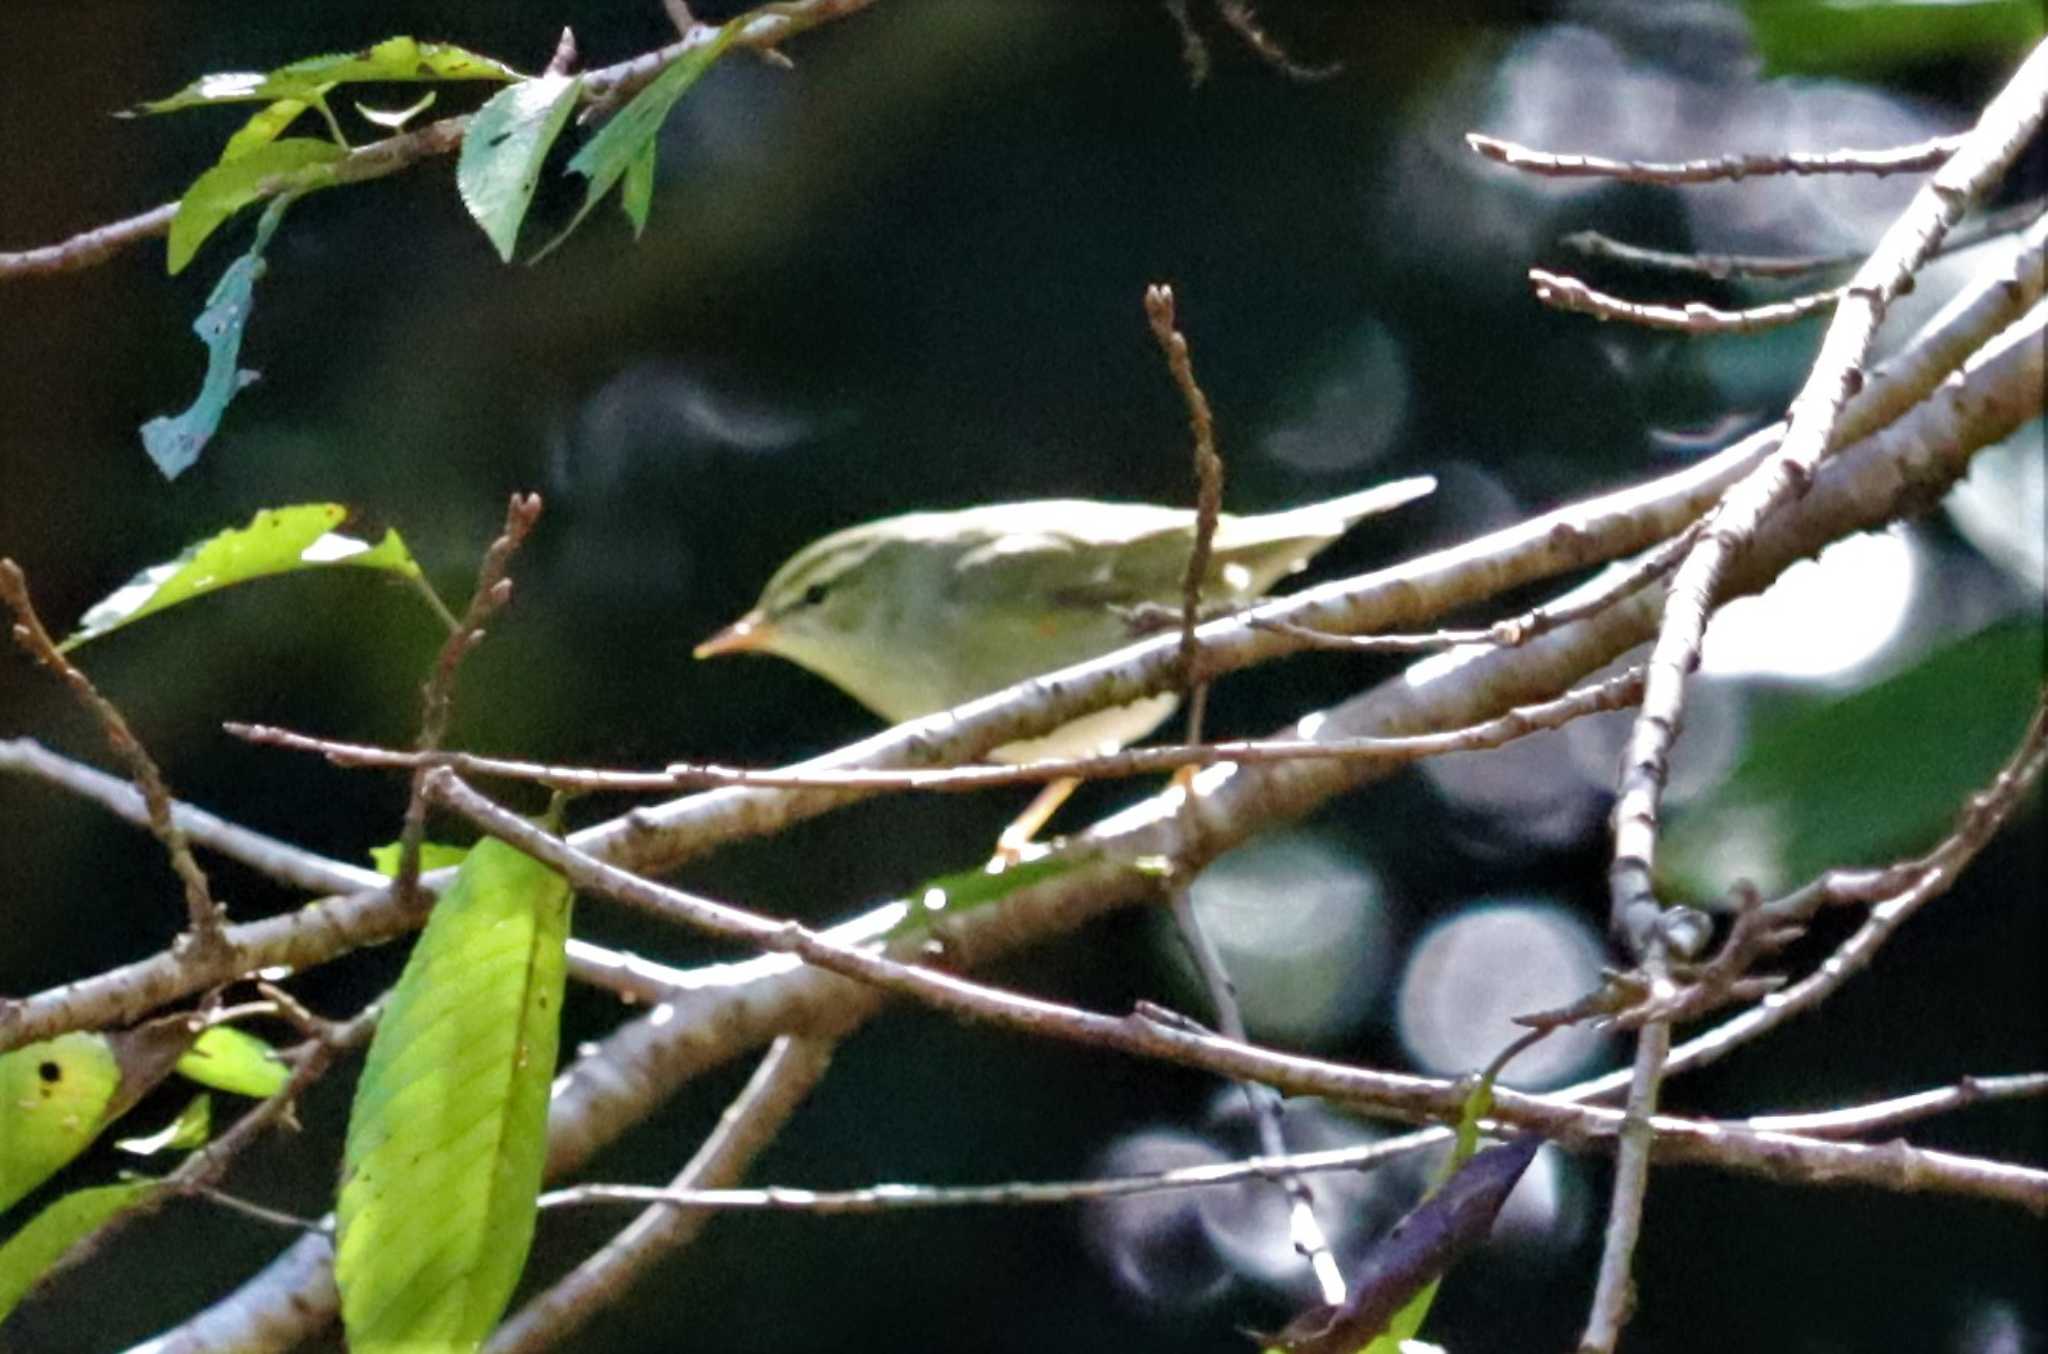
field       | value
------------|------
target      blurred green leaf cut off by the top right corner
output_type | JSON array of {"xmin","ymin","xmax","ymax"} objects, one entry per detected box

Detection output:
[{"xmin": 1743, "ymin": 0, "xmax": 2044, "ymax": 78}]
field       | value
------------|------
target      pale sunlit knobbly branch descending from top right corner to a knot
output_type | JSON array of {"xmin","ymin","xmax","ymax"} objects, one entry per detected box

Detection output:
[{"xmin": 1610, "ymin": 41, "xmax": 2048, "ymax": 953}]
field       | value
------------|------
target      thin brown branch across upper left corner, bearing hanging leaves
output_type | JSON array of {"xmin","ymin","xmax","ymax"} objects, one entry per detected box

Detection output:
[{"xmin": 0, "ymin": 0, "xmax": 874, "ymax": 283}]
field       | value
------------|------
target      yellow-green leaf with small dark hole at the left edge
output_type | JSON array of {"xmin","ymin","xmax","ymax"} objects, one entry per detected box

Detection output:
[{"xmin": 0, "ymin": 1030, "xmax": 121, "ymax": 1213}]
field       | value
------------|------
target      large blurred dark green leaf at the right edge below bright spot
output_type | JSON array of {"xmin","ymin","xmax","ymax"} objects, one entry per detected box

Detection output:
[{"xmin": 1657, "ymin": 617, "xmax": 2048, "ymax": 899}]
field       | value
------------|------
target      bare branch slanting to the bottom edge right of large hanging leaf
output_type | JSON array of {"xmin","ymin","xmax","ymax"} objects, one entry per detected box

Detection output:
[{"xmin": 483, "ymin": 1034, "xmax": 836, "ymax": 1354}]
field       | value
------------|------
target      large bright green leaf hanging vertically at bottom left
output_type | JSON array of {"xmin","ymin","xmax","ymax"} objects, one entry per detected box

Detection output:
[{"xmin": 334, "ymin": 840, "xmax": 569, "ymax": 1354}]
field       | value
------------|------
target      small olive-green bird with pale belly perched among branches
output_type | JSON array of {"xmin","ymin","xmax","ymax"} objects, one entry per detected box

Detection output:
[{"xmin": 696, "ymin": 475, "xmax": 1436, "ymax": 762}]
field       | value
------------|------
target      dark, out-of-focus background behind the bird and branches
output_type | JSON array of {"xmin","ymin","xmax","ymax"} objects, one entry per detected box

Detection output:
[{"xmin": 0, "ymin": 0, "xmax": 2044, "ymax": 1354}]
